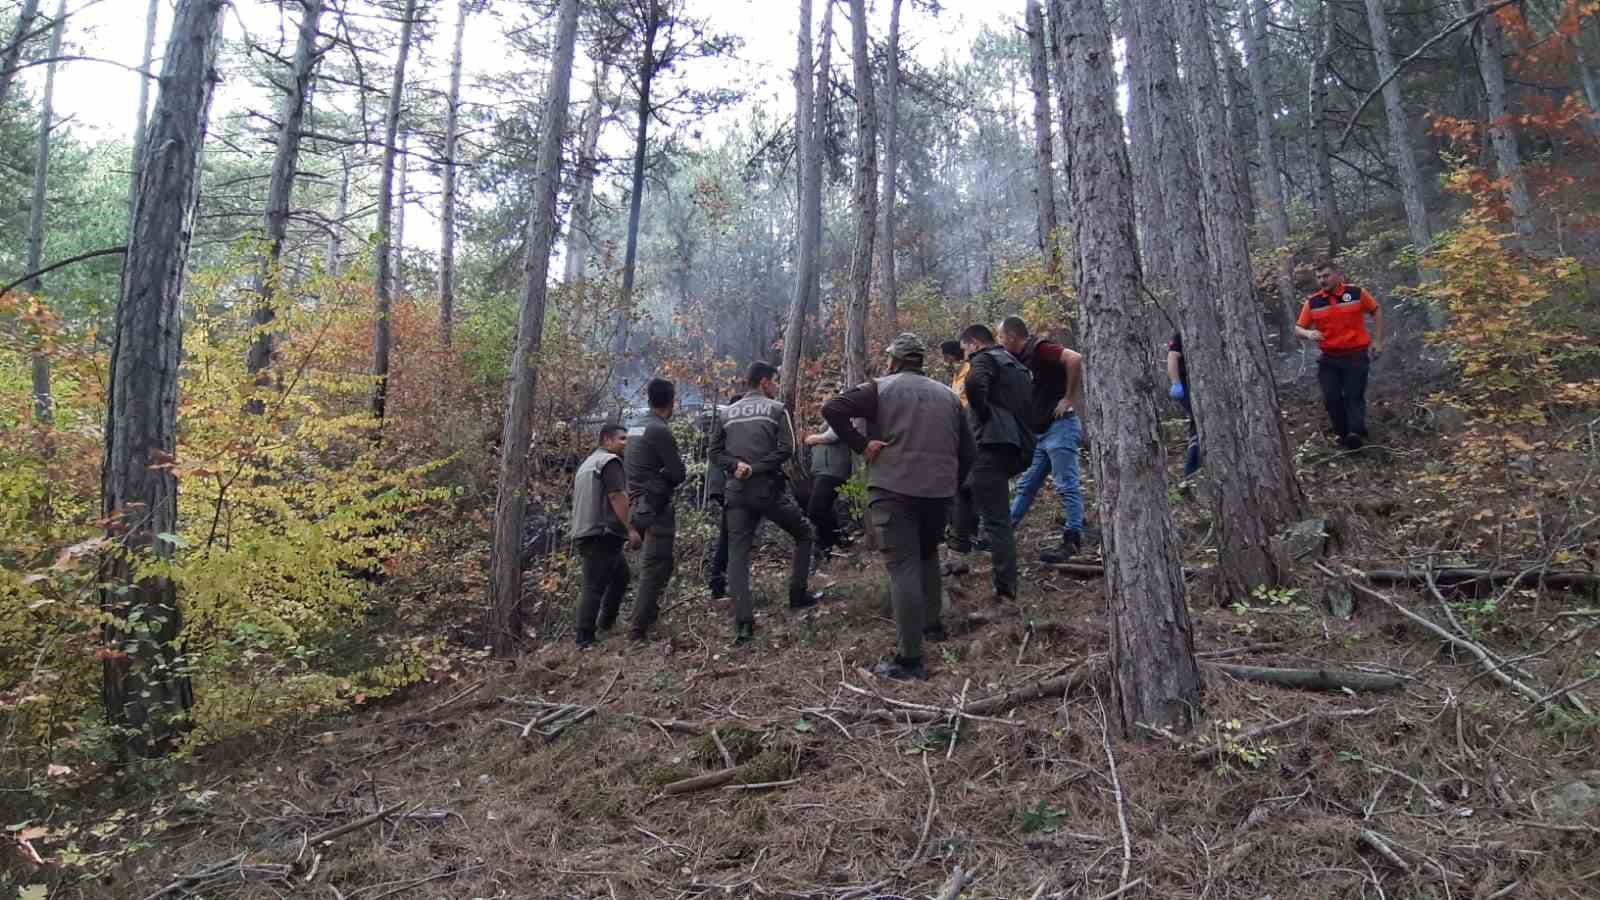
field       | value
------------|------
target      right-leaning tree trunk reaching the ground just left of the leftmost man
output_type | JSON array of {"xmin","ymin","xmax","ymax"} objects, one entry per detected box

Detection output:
[{"xmin": 490, "ymin": 0, "xmax": 578, "ymax": 657}]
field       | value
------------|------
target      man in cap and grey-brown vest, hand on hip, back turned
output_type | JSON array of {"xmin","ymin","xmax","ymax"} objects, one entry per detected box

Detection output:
[{"xmin": 822, "ymin": 331, "xmax": 978, "ymax": 679}]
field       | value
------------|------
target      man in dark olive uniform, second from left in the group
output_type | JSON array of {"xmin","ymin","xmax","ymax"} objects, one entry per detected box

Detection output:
[{"xmin": 624, "ymin": 378, "xmax": 688, "ymax": 641}]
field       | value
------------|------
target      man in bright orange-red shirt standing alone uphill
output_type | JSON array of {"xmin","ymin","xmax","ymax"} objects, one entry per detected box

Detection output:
[{"xmin": 1294, "ymin": 259, "xmax": 1384, "ymax": 450}]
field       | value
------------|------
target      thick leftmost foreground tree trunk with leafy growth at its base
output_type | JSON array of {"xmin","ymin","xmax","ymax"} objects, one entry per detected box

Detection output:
[{"xmin": 99, "ymin": 0, "xmax": 226, "ymax": 754}]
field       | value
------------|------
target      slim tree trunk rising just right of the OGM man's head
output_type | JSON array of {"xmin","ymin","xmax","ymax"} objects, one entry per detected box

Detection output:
[{"xmin": 778, "ymin": 0, "xmax": 832, "ymax": 410}]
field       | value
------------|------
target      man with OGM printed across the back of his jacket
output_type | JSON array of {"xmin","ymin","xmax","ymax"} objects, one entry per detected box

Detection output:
[{"xmin": 710, "ymin": 362, "xmax": 816, "ymax": 644}]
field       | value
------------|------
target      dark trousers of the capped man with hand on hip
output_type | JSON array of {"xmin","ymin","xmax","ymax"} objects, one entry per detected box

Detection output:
[{"xmin": 867, "ymin": 488, "xmax": 950, "ymax": 660}]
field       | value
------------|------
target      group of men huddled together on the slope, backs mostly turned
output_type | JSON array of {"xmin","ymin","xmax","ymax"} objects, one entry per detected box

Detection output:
[{"xmin": 571, "ymin": 317, "xmax": 1083, "ymax": 679}]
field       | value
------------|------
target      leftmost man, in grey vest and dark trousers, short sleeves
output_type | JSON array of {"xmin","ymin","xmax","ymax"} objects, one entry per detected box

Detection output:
[{"xmin": 571, "ymin": 424, "xmax": 640, "ymax": 647}]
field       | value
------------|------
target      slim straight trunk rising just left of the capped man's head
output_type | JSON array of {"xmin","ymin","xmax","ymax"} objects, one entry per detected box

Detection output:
[{"xmin": 845, "ymin": 0, "xmax": 878, "ymax": 384}]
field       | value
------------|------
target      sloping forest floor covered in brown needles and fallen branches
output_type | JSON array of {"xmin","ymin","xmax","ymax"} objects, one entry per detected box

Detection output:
[{"xmin": 6, "ymin": 339, "xmax": 1600, "ymax": 900}]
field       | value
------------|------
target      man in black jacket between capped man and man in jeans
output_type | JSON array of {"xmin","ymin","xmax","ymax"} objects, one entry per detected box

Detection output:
[{"xmin": 957, "ymin": 325, "xmax": 1035, "ymax": 601}]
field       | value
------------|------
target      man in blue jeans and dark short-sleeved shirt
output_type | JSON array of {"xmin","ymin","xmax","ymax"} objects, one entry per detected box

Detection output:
[{"xmin": 1000, "ymin": 315, "xmax": 1083, "ymax": 564}]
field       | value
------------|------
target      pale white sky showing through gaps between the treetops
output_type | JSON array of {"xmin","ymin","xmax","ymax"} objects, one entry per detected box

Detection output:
[{"xmin": 27, "ymin": 0, "xmax": 1022, "ymax": 248}]
